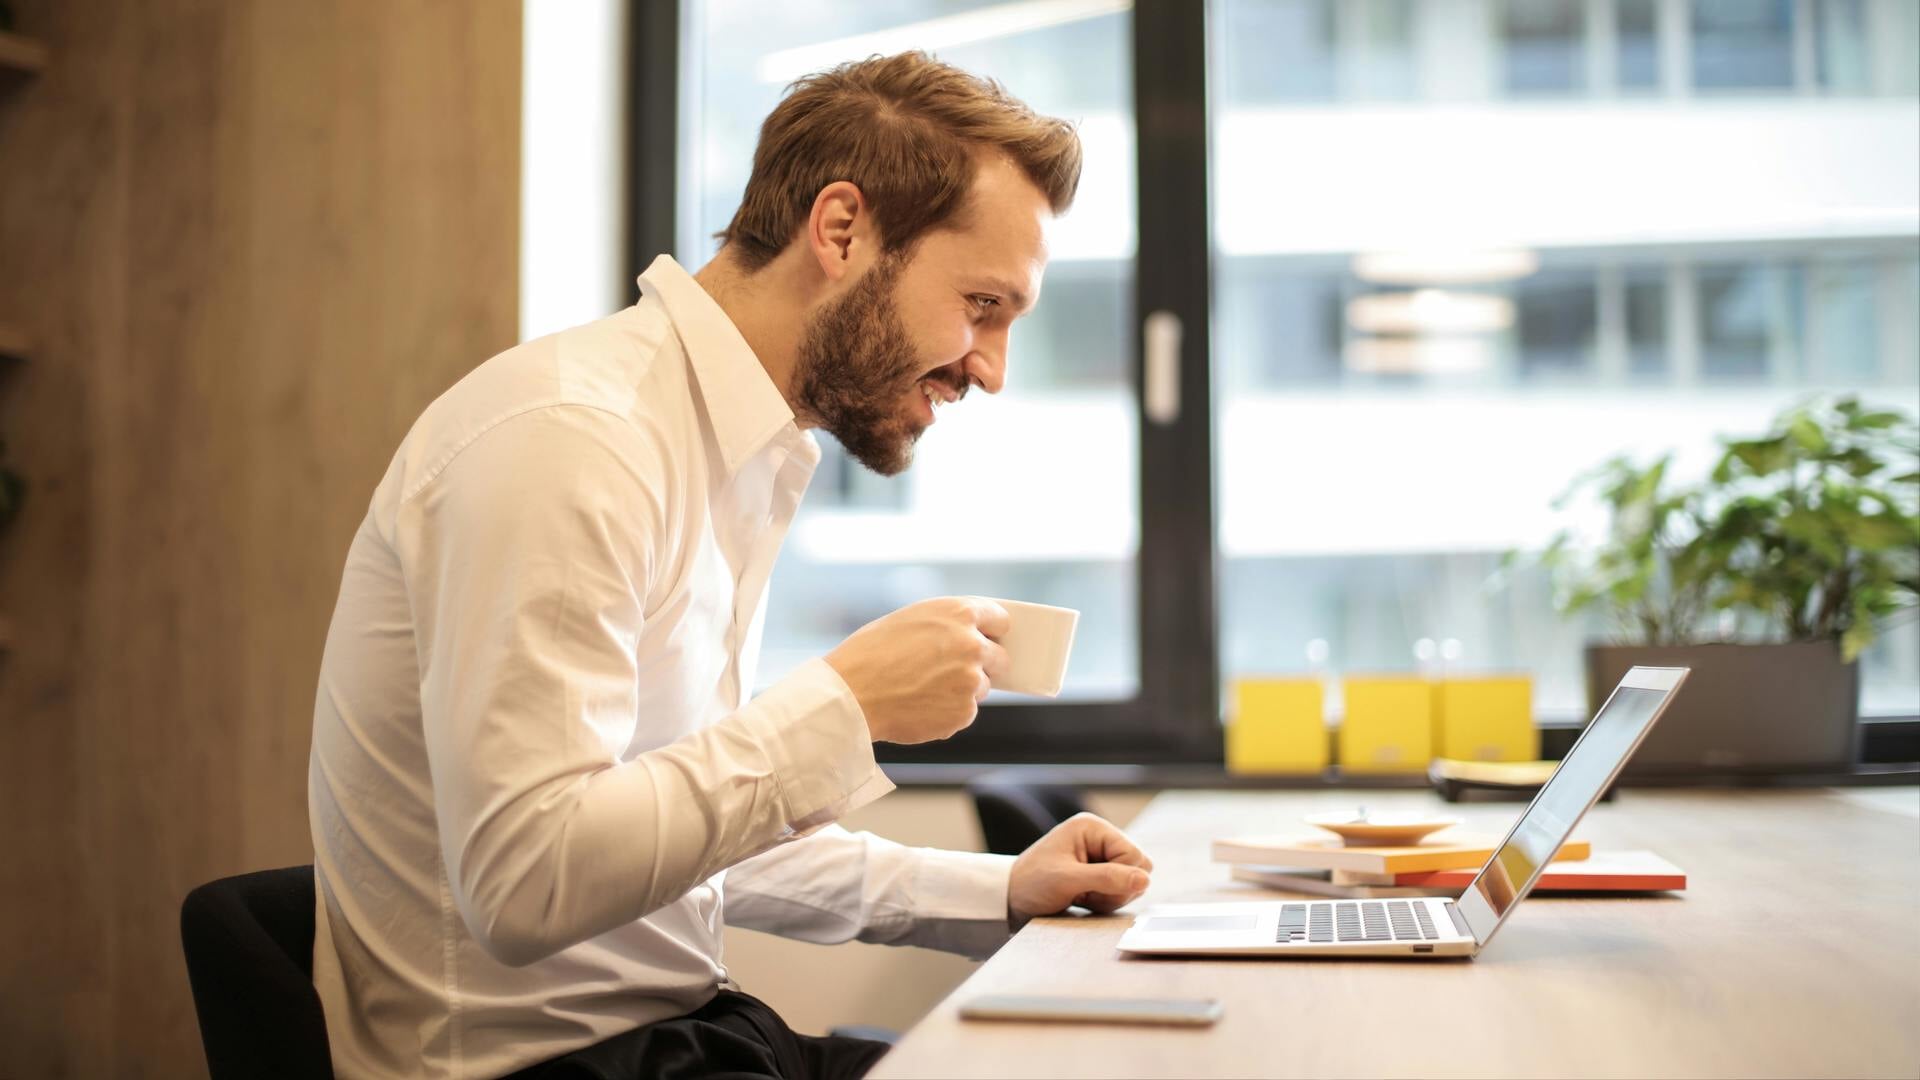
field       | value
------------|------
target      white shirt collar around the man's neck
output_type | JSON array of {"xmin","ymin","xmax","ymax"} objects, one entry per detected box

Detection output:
[{"xmin": 639, "ymin": 256, "xmax": 799, "ymax": 475}]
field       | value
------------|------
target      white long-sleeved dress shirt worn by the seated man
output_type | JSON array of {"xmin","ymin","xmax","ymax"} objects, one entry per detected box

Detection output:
[{"xmin": 307, "ymin": 256, "xmax": 1010, "ymax": 1078}]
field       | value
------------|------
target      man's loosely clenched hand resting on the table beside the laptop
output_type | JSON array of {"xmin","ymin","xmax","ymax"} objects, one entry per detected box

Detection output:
[{"xmin": 1006, "ymin": 813, "xmax": 1154, "ymax": 930}]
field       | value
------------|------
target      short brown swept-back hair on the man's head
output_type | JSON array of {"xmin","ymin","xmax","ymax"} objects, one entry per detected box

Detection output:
[{"xmin": 718, "ymin": 52, "xmax": 1081, "ymax": 273}]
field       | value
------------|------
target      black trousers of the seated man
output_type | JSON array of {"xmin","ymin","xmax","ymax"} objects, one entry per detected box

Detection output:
[{"xmin": 507, "ymin": 990, "xmax": 889, "ymax": 1080}]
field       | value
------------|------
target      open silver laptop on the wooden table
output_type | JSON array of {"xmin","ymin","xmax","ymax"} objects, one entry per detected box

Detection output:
[{"xmin": 1119, "ymin": 667, "xmax": 1690, "ymax": 957}]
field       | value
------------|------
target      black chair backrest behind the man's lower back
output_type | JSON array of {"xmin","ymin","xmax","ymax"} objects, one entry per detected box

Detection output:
[{"xmin": 180, "ymin": 867, "xmax": 334, "ymax": 1080}]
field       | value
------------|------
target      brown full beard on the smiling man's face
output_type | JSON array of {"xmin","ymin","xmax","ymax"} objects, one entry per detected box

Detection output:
[{"xmin": 793, "ymin": 256, "xmax": 944, "ymax": 477}]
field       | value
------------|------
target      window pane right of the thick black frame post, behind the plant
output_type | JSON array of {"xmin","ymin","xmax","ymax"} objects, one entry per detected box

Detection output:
[{"xmin": 1212, "ymin": 0, "xmax": 1920, "ymax": 717}]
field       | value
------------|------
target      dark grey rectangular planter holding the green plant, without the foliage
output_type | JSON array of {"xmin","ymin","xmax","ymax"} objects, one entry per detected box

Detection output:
[{"xmin": 1586, "ymin": 642, "xmax": 1860, "ymax": 776}]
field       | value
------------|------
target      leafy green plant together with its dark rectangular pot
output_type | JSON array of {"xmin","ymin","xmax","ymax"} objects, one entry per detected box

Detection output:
[{"xmin": 1544, "ymin": 398, "xmax": 1920, "ymax": 773}]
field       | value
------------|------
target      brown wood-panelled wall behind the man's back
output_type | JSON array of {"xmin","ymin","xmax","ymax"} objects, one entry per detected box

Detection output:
[{"xmin": 0, "ymin": 0, "xmax": 520, "ymax": 1080}]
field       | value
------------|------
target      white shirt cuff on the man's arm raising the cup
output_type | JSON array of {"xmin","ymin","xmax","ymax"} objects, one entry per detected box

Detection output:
[{"xmin": 743, "ymin": 645, "xmax": 893, "ymax": 840}]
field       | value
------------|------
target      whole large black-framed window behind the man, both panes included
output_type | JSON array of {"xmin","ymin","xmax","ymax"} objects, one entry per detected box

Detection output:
[{"xmin": 637, "ymin": 0, "xmax": 1920, "ymax": 761}]
